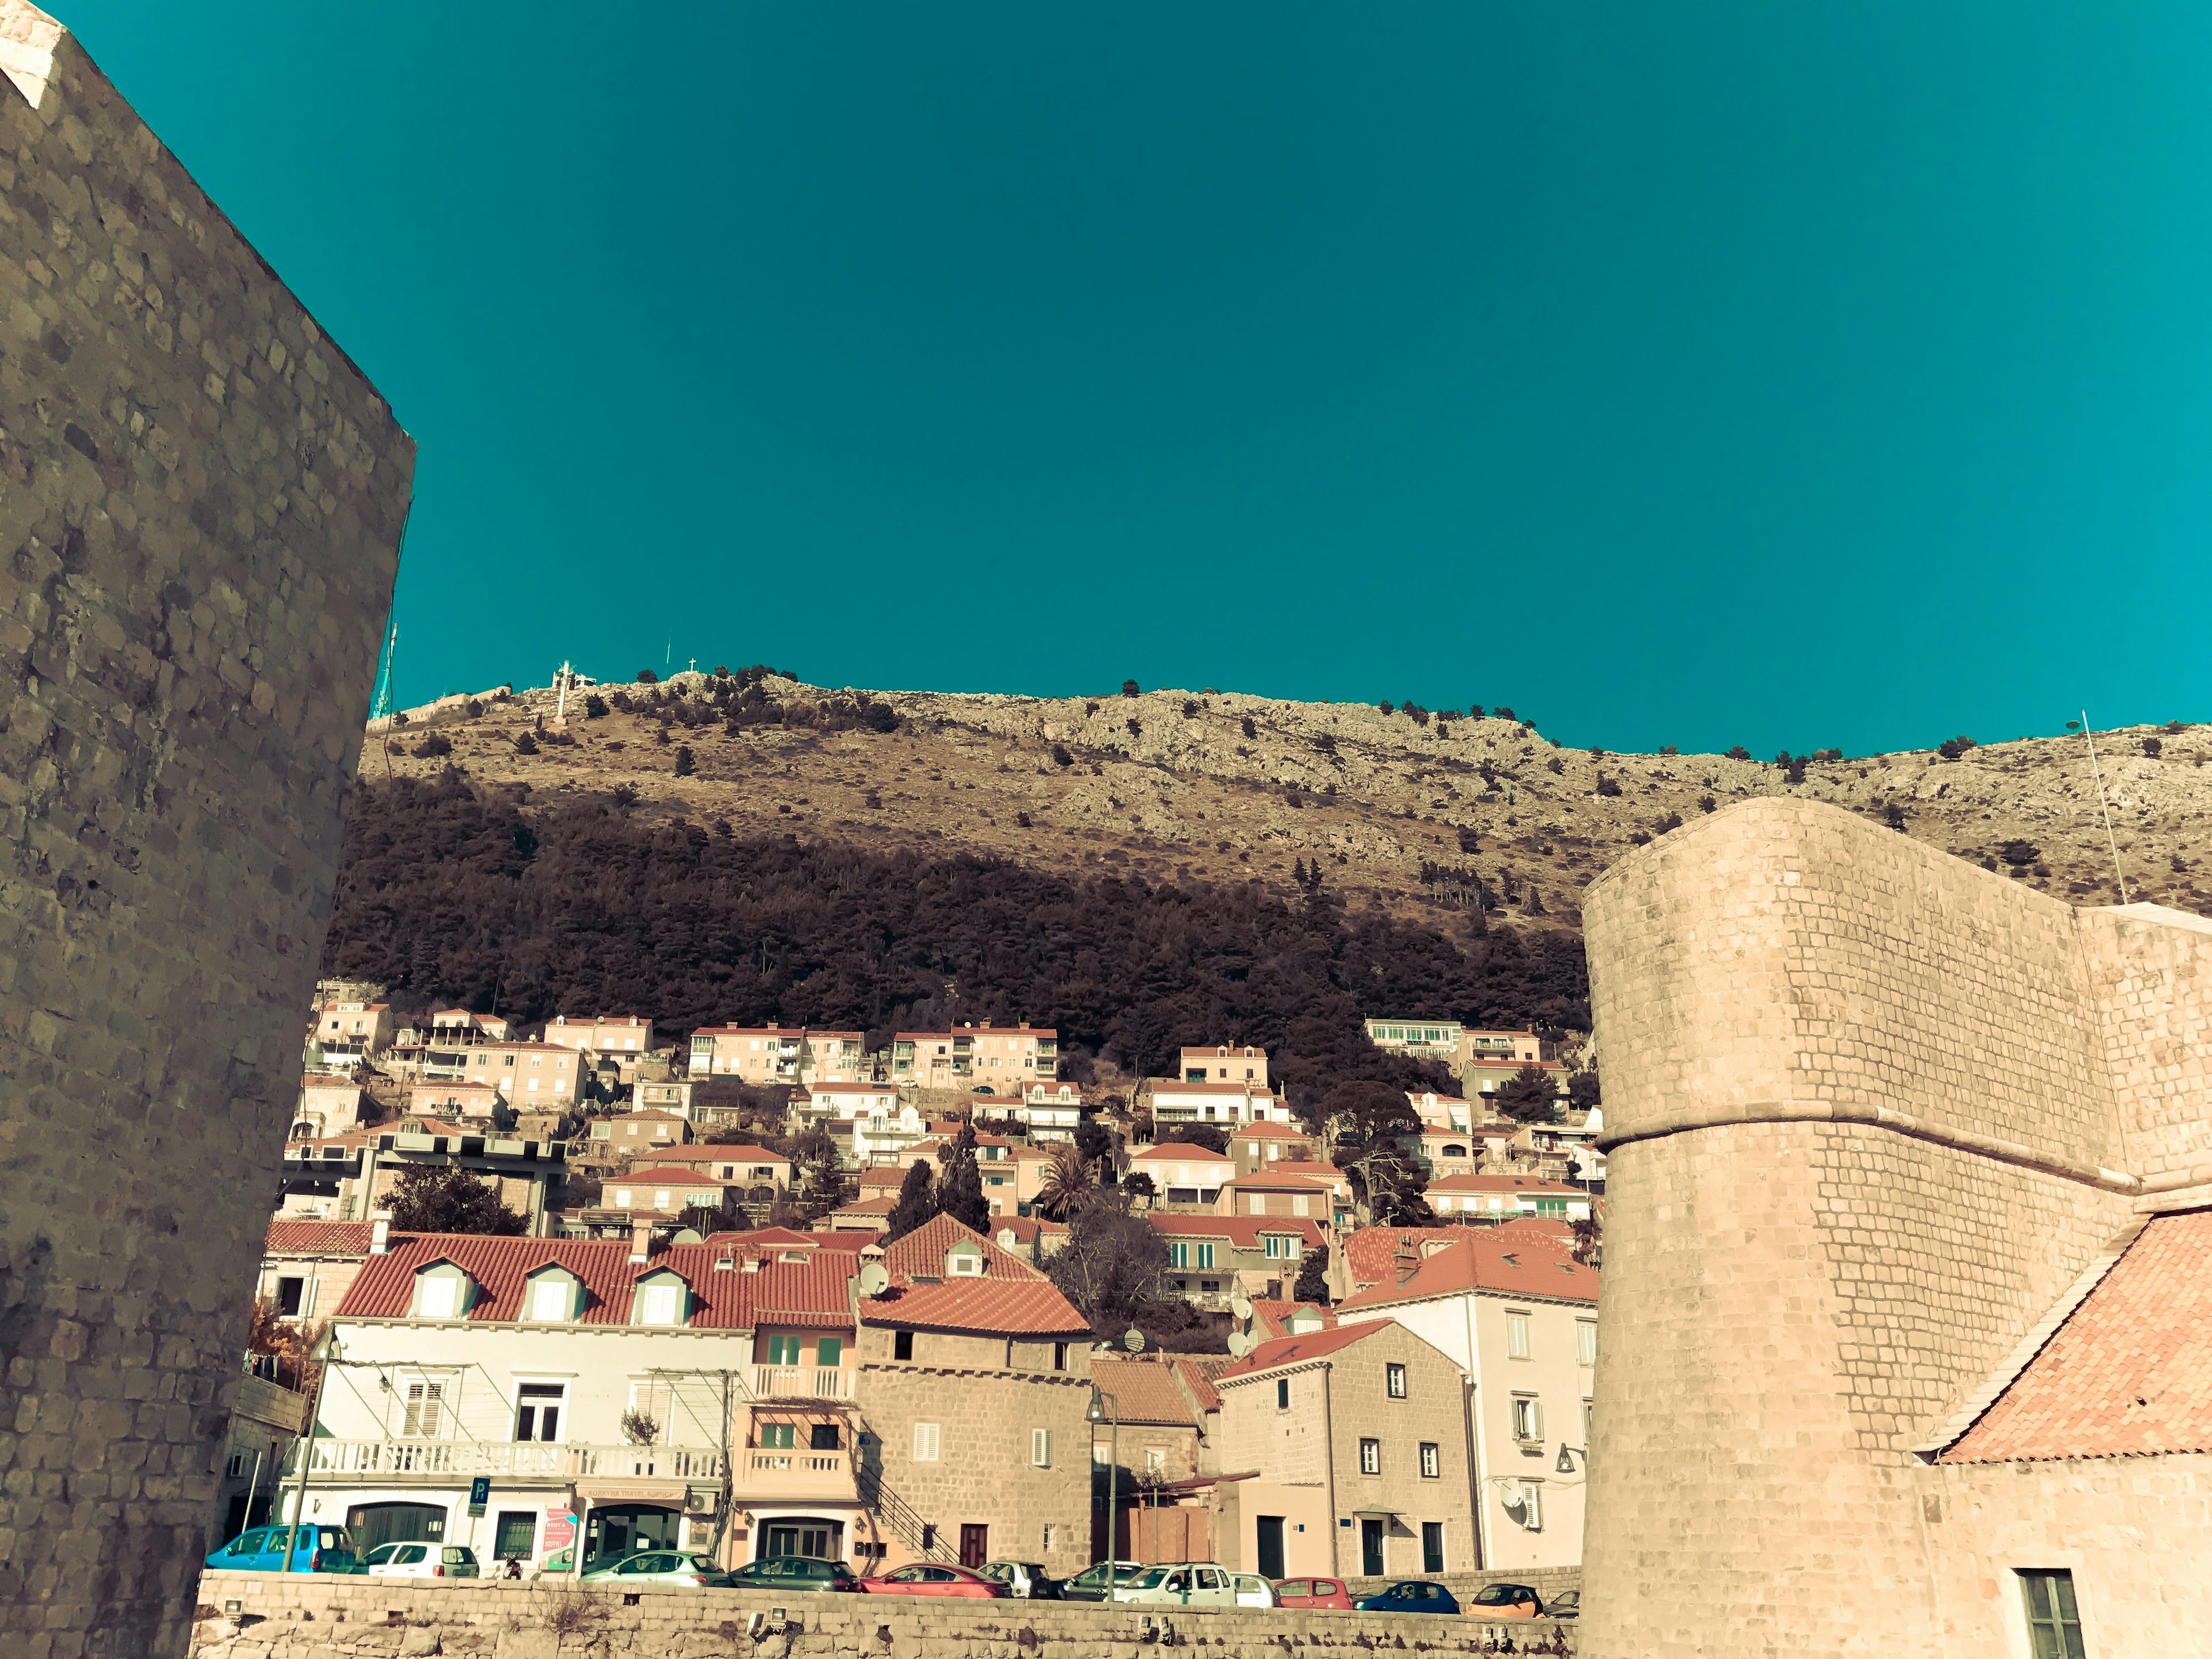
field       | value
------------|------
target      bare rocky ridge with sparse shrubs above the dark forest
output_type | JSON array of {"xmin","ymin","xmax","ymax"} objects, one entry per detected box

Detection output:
[{"xmin": 363, "ymin": 675, "xmax": 2212, "ymax": 927}]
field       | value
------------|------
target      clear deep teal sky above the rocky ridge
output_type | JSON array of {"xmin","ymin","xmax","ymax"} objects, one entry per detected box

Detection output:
[{"xmin": 55, "ymin": 0, "xmax": 2212, "ymax": 754}]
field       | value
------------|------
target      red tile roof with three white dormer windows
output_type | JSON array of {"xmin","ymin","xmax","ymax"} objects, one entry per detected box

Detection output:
[{"xmin": 339, "ymin": 1232, "xmax": 851, "ymax": 1330}]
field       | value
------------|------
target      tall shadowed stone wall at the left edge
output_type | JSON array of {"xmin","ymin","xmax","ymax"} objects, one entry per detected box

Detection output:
[{"xmin": 0, "ymin": 0, "xmax": 414, "ymax": 1659}]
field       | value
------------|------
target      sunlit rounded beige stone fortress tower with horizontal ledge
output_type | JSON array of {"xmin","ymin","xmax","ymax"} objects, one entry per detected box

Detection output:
[{"xmin": 1584, "ymin": 798, "xmax": 2212, "ymax": 1659}]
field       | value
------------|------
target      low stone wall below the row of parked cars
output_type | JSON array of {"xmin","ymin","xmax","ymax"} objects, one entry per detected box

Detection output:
[{"xmin": 192, "ymin": 1573, "xmax": 1575, "ymax": 1659}]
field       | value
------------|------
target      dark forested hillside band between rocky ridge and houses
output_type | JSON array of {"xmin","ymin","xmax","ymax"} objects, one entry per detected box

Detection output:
[{"xmin": 323, "ymin": 772, "xmax": 1588, "ymax": 1104}]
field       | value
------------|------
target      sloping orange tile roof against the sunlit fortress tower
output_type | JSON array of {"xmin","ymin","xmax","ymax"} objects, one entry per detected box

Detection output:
[{"xmin": 1938, "ymin": 1210, "xmax": 2212, "ymax": 1462}]
